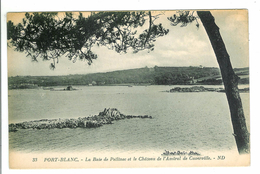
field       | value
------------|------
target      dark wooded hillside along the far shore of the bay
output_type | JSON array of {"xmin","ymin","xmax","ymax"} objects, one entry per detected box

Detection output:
[{"xmin": 8, "ymin": 66, "xmax": 249, "ymax": 89}]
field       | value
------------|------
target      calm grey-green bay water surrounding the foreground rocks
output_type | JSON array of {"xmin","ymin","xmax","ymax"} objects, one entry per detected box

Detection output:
[{"xmin": 8, "ymin": 86, "xmax": 249, "ymax": 152}]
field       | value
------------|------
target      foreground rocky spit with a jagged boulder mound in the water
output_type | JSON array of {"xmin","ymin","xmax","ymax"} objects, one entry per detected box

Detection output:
[{"xmin": 9, "ymin": 108, "xmax": 152, "ymax": 132}]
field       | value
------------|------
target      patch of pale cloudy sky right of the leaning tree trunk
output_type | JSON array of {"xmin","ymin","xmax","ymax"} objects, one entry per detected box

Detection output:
[{"xmin": 212, "ymin": 10, "xmax": 249, "ymax": 67}]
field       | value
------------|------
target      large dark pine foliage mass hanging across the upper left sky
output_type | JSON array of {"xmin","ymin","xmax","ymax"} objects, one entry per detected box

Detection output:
[{"xmin": 7, "ymin": 11, "xmax": 169, "ymax": 69}]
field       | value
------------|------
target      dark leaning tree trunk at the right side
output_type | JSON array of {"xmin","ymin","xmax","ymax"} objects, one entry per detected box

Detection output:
[{"xmin": 197, "ymin": 11, "xmax": 250, "ymax": 154}]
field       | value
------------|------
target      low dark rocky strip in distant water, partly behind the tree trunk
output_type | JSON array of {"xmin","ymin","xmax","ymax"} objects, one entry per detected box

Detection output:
[{"xmin": 166, "ymin": 86, "xmax": 249, "ymax": 93}]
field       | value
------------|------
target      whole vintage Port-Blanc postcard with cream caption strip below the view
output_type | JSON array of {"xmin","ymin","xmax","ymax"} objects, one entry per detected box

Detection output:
[{"xmin": 7, "ymin": 9, "xmax": 250, "ymax": 169}]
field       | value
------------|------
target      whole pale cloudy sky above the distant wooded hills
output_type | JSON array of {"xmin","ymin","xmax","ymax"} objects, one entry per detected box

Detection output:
[{"xmin": 7, "ymin": 10, "xmax": 249, "ymax": 76}]
